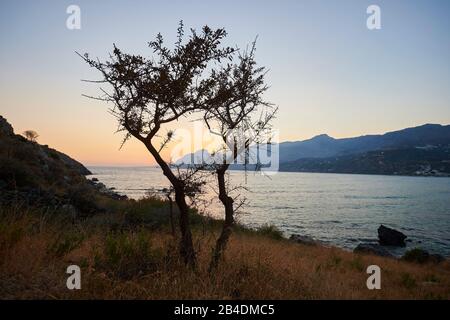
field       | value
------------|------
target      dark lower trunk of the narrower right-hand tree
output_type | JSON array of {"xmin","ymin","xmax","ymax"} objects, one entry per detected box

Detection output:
[{"xmin": 209, "ymin": 170, "xmax": 234, "ymax": 272}]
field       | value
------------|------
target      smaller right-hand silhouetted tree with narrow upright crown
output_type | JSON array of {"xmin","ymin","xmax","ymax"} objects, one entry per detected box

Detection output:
[{"xmin": 204, "ymin": 42, "xmax": 277, "ymax": 270}]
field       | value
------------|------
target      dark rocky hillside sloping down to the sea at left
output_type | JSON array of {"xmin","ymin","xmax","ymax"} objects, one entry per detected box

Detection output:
[{"xmin": 0, "ymin": 116, "xmax": 121, "ymax": 214}]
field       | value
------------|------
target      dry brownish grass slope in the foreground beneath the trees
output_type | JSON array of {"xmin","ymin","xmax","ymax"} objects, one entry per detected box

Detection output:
[{"xmin": 0, "ymin": 208, "xmax": 450, "ymax": 299}]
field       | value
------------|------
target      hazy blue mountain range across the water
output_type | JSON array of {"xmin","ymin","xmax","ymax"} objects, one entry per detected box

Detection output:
[{"xmin": 177, "ymin": 124, "xmax": 450, "ymax": 176}]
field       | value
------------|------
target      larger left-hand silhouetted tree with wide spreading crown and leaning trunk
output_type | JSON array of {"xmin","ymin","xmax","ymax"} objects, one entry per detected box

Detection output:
[{"xmin": 82, "ymin": 23, "xmax": 235, "ymax": 266}]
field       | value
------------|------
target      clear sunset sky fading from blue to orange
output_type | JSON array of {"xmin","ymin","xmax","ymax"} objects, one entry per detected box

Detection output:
[{"xmin": 0, "ymin": 0, "xmax": 450, "ymax": 165}]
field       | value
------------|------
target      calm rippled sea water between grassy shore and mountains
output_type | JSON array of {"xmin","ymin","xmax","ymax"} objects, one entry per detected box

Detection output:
[{"xmin": 89, "ymin": 167, "xmax": 450, "ymax": 256}]
